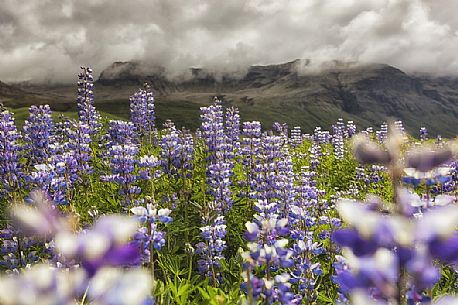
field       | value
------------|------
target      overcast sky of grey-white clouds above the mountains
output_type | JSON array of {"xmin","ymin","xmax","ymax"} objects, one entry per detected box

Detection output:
[{"xmin": 0, "ymin": 0, "xmax": 458, "ymax": 82}]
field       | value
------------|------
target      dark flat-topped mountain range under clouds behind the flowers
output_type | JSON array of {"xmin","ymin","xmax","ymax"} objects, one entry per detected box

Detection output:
[{"xmin": 3, "ymin": 60, "xmax": 458, "ymax": 137}]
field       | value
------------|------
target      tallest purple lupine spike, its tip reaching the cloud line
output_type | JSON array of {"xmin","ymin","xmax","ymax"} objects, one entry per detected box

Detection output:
[{"xmin": 76, "ymin": 66, "xmax": 102, "ymax": 135}]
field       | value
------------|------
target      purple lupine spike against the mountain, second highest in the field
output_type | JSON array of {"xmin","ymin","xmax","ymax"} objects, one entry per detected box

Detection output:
[{"xmin": 129, "ymin": 87, "xmax": 156, "ymax": 136}]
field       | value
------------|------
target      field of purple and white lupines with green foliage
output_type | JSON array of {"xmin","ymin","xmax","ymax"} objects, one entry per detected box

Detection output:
[{"xmin": 0, "ymin": 67, "xmax": 458, "ymax": 305}]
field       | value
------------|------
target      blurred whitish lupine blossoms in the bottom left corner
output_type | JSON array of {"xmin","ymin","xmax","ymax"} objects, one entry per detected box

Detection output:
[{"xmin": 0, "ymin": 264, "xmax": 154, "ymax": 305}]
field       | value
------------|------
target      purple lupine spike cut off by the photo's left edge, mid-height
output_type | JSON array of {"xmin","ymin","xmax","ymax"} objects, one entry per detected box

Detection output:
[{"xmin": 0, "ymin": 110, "xmax": 22, "ymax": 198}]
